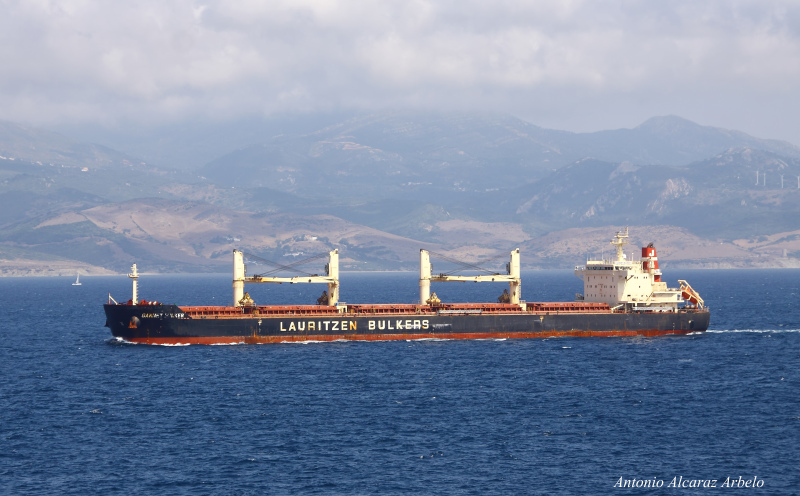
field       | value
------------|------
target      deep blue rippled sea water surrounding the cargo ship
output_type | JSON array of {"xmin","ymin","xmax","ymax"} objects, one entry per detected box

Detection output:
[{"xmin": 0, "ymin": 270, "xmax": 800, "ymax": 495}]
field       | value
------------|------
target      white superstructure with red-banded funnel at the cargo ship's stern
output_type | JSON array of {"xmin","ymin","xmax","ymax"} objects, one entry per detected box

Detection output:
[{"xmin": 575, "ymin": 228, "xmax": 703, "ymax": 312}]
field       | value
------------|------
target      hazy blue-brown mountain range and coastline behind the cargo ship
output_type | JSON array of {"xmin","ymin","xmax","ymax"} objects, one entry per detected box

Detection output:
[{"xmin": 0, "ymin": 113, "xmax": 800, "ymax": 274}]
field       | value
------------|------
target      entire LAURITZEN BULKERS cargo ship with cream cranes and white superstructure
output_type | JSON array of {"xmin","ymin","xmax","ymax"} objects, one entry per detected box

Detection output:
[{"xmin": 104, "ymin": 229, "xmax": 710, "ymax": 345}]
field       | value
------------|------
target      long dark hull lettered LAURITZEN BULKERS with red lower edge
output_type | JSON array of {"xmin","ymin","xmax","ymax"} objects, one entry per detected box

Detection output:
[{"xmin": 104, "ymin": 304, "xmax": 709, "ymax": 344}]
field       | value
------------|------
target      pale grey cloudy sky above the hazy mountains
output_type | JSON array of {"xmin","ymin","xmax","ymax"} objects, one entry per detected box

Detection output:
[{"xmin": 0, "ymin": 0, "xmax": 800, "ymax": 145}]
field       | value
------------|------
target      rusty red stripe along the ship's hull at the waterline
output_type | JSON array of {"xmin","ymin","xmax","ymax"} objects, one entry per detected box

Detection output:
[{"xmin": 126, "ymin": 329, "xmax": 697, "ymax": 345}]
